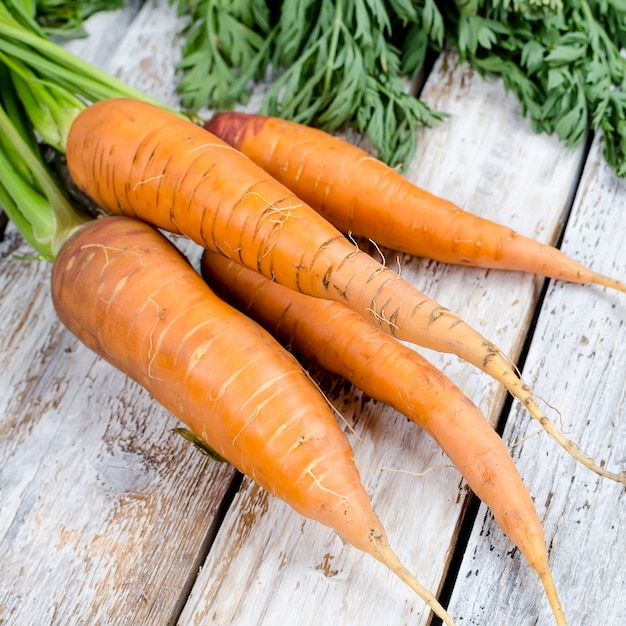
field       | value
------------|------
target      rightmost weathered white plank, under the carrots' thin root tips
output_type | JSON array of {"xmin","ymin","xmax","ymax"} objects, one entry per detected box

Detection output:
[{"xmin": 451, "ymin": 130, "xmax": 626, "ymax": 626}]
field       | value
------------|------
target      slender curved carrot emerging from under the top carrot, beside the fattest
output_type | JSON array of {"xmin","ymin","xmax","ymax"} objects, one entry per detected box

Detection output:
[{"xmin": 202, "ymin": 251, "xmax": 565, "ymax": 624}]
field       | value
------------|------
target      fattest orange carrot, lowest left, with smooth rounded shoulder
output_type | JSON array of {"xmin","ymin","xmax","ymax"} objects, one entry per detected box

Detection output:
[{"xmin": 52, "ymin": 217, "xmax": 452, "ymax": 624}]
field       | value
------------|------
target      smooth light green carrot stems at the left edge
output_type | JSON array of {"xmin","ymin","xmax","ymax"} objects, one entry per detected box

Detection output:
[{"xmin": 0, "ymin": 3, "xmax": 185, "ymax": 260}]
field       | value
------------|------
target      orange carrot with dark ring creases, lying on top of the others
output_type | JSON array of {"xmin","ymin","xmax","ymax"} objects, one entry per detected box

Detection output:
[{"xmin": 66, "ymin": 98, "xmax": 626, "ymax": 483}]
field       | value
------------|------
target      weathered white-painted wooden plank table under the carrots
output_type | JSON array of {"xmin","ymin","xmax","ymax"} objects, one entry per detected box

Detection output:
[{"xmin": 0, "ymin": 0, "xmax": 626, "ymax": 626}]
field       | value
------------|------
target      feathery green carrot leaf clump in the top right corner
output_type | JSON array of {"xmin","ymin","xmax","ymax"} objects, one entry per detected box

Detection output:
[{"xmin": 445, "ymin": 0, "xmax": 626, "ymax": 176}]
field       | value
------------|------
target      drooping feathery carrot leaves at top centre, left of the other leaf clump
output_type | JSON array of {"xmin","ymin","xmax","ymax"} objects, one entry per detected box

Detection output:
[{"xmin": 171, "ymin": 0, "xmax": 444, "ymax": 168}]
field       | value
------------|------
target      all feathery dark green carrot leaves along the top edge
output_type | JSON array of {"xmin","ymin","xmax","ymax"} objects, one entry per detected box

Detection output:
[{"xmin": 172, "ymin": 0, "xmax": 626, "ymax": 176}]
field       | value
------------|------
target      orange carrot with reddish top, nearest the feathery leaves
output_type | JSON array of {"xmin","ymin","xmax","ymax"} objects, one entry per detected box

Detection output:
[{"xmin": 205, "ymin": 112, "xmax": 626, "ymax": 292}]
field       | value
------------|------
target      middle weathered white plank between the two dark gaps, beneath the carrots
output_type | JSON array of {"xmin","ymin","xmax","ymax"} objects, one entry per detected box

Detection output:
[{"xmin": 180, "ymin": 54, "xmax": 582, "ymax": 626}]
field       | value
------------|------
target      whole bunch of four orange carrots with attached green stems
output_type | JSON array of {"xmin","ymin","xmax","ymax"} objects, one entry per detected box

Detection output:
[{"xmin": 0, "ymin": 12, "xmax": 626, "ymax": 624}]
